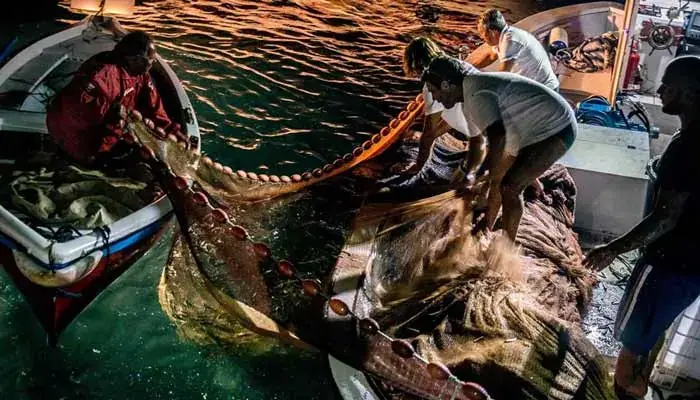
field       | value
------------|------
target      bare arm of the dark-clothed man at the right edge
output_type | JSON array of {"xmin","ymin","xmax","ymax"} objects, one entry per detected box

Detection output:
[{"xmin": 584, "ymin": 187, "xmax": 690, "ymax": 271}]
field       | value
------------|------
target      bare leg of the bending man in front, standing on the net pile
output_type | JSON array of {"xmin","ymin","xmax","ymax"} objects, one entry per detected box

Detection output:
[{"xmin": 500, "ymin": 126, "xmax": 568, "ymax": 241}]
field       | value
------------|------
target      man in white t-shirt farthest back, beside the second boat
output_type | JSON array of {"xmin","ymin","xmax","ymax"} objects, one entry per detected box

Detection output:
[{"xmin": 468, "ymin": 9, "xmax": 559, "ymax": 91}]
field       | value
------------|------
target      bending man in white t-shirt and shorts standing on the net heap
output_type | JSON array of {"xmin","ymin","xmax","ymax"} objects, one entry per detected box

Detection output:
[{"xmin": 421, "ymin": 56, "xmax": 576, "ymax": 241}]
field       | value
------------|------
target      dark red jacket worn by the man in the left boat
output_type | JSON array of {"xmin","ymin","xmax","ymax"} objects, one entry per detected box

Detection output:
[{"xmin": 46, "ymin": 53, "xmax": 180, "ymax": 163}]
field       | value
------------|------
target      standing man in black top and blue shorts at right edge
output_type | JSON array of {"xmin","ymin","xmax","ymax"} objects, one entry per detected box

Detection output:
[{"xmin": 585, "ymin": 56, "xmax": 700, "ymax": 399}]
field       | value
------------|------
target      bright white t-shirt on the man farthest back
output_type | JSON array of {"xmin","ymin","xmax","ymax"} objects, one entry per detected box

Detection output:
[{"xmin": 494, "ymin": 25, "xmax": 559, "ymax": 90}]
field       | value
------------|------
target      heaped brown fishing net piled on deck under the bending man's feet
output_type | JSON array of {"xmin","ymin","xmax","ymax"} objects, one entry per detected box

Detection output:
[{"xmin": 348, "ymin": 166, "xmax": 614, "ymax": 399}]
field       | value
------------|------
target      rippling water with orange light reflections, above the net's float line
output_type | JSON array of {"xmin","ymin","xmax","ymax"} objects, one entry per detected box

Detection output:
[{"xmin": 58, "ymin": 0, "xmax": 537, "ymax": 174}]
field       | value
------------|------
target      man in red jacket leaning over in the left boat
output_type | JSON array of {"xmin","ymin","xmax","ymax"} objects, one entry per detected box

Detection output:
[{"xmin": 46, "ymin": 32, "xmax": 184, "ymax": 168}]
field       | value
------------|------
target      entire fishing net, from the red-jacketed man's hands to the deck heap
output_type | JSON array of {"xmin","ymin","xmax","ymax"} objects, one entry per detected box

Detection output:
[{"xmin": 127, "ymin": 108, "xmax": 613, "ymax": 399}]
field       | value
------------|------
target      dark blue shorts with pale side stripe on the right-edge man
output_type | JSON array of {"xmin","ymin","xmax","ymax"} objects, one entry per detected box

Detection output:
[{"xmin": 615, "ymin": 262, "xmax": 700, "ymax": 355}]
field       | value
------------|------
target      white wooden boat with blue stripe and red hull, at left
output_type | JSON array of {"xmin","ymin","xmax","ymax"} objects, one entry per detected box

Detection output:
[{"xmin": 0, "ymin": 16, "xmax": 199, "ymax": 342}]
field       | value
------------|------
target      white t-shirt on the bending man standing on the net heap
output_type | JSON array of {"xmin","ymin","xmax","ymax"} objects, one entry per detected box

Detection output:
[{"xmin": 463, "ymin": 72, "xmax": 576, "ymax": 156}]
